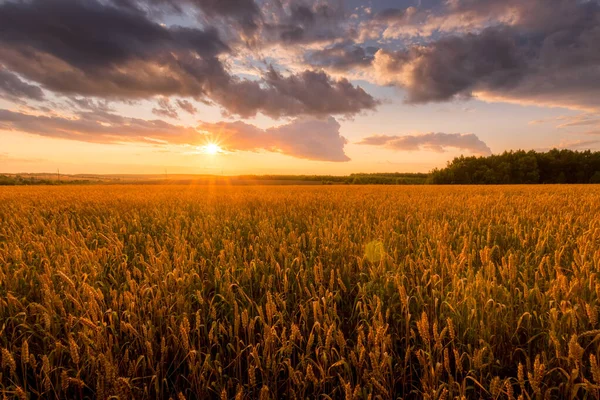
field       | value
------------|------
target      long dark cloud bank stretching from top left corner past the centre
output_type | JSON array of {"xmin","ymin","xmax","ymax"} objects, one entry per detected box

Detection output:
[{"xmin": 0, "ymin": 0, "xmax": 377, "ymax": 116}]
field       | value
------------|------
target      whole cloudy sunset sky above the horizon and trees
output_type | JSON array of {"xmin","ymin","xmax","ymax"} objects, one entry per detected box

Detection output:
[{"xmin": 0, "ymin": 0, "xmax": 600, "ymax": 174}]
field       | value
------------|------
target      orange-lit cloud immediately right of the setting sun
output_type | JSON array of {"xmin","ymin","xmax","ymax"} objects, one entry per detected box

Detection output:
[{"xmin": 199, "ymin": 117, "xmax": 350, "ymax": 162}]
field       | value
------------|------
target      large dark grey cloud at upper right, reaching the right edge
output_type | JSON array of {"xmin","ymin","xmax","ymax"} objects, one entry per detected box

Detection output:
[{"xmin": 374, "ymin": 0, "xmax": 600, "ymax": 110}]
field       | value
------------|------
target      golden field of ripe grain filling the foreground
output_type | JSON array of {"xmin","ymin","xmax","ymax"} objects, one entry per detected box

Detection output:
[{"xmin": 0, "ymin": 186, "xmax": 600, "ymax": 400}]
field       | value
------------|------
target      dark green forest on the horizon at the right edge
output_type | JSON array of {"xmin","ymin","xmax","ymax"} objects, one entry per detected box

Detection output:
[{"xmin": 428, "ymin": 149, "xmax": 600, "ymax": 185}]
